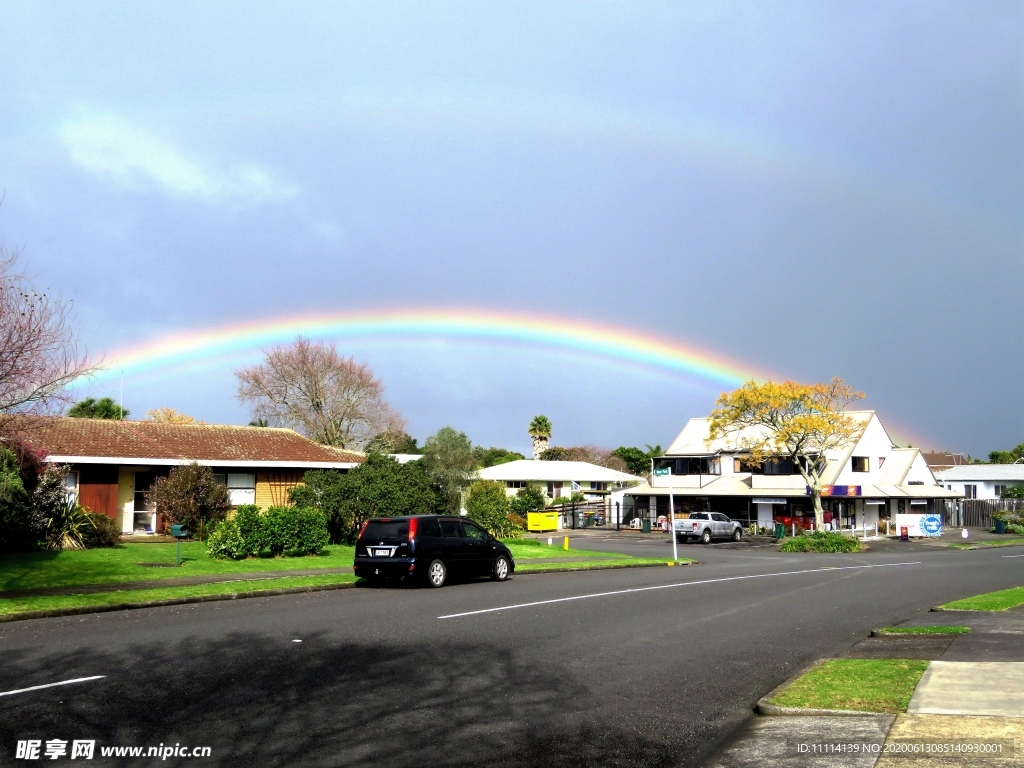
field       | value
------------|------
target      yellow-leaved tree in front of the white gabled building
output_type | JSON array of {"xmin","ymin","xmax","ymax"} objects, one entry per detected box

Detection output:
[{"xmin": 708, "ymin": 377, "xmax": 864, "ymax": 530}]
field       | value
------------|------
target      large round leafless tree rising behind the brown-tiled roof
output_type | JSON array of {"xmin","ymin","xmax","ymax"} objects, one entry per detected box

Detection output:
[{"xmin": 234, "ymin": 336, "xmax": 406, "ymax": 451}]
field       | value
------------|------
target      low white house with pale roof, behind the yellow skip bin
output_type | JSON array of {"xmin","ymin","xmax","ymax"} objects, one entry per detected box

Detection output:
[{"xmin": 476, "ymin": 459, "xmax": 640, "ymax": 500}]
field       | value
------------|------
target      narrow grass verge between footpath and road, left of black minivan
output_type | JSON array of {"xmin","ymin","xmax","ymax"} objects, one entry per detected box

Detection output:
[{"xmin": 0, "ymin": 573, "xmax": 355, "ymax": 615}]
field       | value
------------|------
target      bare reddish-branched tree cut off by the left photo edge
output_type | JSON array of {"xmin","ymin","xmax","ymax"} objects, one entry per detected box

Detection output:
[{"xmin": 0, "ymin": 247, "xmax": 94, "ymax": 433}]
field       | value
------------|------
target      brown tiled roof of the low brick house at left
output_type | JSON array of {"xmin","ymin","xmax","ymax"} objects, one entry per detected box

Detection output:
[{"xmin": 22, "ymin": 416, "xmax": 364, "ymax": 464}]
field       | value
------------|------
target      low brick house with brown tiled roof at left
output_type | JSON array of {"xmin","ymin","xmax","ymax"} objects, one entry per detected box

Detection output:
[{"xmin": 24, "ymin": 417, "xmax": 364, "ymax": 534}]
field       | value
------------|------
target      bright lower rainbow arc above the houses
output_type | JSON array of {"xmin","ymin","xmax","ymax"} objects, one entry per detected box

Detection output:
[{"xmin": 94, "ymin": 307, "xmax": 771, "ymax": 389}]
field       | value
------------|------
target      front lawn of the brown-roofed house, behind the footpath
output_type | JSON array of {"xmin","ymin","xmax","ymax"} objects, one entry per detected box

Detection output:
[{"xmin": 0, "ymin": 542, "xmax": 354, "ymax": 592}]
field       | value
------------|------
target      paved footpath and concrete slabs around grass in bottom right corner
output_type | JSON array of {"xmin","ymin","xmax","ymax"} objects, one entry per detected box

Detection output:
[{"xmin": 706, "ymin": 609, "xmax": 1024, "ymax": 768}]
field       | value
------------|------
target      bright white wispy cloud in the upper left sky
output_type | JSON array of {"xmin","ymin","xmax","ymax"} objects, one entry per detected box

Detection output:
[{"xmin": 60, "ymin": 117, "xmax": 295, "ymax": 203}]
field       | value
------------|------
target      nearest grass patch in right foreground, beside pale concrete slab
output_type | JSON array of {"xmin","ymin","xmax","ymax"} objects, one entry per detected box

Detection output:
[{"xmin": 770, "ymin": 658, "xmax": 928, "ymax": 715}]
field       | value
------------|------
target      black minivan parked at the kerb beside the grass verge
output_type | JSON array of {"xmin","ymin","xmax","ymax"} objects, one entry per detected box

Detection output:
[{"xmin": 354, "ymin": 515, "xmax": 515, "ymax": 587}]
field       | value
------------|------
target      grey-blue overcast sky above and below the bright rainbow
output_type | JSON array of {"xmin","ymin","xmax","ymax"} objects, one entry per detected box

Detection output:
[{"xmin": 0, "ymin": 0, "xmax": 1024, "ymax": 456}]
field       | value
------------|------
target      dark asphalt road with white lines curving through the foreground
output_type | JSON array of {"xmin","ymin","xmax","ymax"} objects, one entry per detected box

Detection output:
[{"xmin": 0, "ymin": 542, "xmax": 1024, "ymax": 766}]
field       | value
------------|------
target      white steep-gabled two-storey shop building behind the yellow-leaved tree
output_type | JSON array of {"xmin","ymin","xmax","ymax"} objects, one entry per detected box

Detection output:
[{"xmin": 622, "ymin": 411, "xmax": 961, "ymax": 529}]
